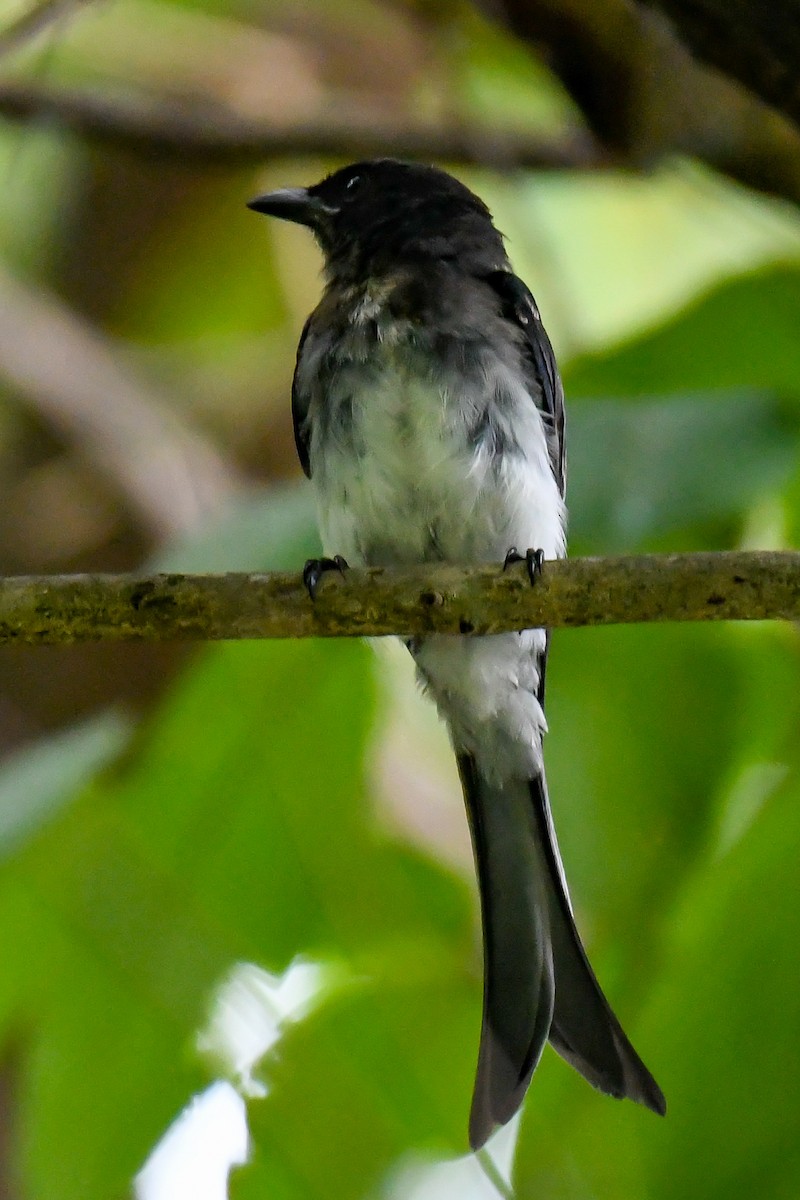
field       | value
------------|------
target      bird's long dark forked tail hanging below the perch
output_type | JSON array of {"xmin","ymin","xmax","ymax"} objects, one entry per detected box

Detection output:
[{"xmin": 458, "ymin": 755, "xmax": 666, "ymax": 1148}]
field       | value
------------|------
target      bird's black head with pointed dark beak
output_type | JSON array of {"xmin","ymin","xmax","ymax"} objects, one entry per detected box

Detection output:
[{"xmin": 249, "ymin": 158, "xmax": 506, "ymax": 280}]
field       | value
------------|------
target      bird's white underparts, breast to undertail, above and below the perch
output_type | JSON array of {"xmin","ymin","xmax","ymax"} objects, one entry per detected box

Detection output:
[{"xmin": 308, "ymin": 300, "xmax": 565, "ymax": 780}]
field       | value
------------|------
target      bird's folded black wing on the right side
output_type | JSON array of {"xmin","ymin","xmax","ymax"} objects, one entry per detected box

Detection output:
[{"xmin": 486, "ymin": 271, "xmax": 566, "ymax": 496}]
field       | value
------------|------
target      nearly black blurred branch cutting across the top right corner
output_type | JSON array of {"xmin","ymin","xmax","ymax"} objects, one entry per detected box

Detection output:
[{"xmin": 637, "ymin": 0, "xmax": 800, "ymax": 125}]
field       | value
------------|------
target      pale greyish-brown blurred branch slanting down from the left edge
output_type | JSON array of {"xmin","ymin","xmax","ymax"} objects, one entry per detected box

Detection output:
[{"xmin": 0, "ymin": 274, "xmax": 239, "ymax": 538}]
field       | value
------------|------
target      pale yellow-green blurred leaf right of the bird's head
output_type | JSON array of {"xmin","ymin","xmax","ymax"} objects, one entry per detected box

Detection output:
[{"xmin": 501, "ymin": 170, "xmax": 800, "ymax": 355}]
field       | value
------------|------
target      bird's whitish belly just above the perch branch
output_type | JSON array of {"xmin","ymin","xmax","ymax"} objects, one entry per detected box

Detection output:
[{"xmin": 311, "ymin": 354, "xmax": 565, "ymax": 565}]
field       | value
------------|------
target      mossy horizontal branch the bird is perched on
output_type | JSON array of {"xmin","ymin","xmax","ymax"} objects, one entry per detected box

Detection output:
[{"xmin": 0, "ymin": 551, "xmax": 800, "ymax": 644}]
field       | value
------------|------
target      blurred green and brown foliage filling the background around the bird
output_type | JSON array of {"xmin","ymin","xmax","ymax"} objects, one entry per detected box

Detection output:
[{"xmin": 0, "ymin": 0, "xmax": 800, "ymax": 1200}]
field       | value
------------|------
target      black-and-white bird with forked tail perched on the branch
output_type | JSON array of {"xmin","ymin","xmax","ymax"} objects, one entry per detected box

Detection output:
[{"xmin": 248, "ymin": 158, "xmax": 666, "ymax": 1150}]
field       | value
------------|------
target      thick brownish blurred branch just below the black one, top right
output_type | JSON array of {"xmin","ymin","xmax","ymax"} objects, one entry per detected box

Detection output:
[{"xmin": 489, "ymin": 0, "xmax": 800, "ymax": 203}]
